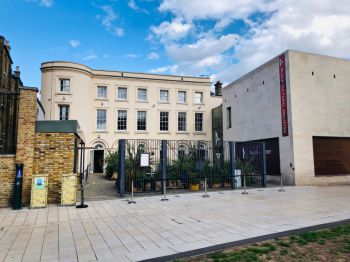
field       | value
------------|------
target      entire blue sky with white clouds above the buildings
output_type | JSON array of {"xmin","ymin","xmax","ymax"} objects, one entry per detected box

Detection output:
[{"xmin": 0, "ymin": 0, "xmax": 350, "ymax": 87}]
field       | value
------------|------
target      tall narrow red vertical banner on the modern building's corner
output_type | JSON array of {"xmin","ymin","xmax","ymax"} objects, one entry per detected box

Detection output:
[{"xmin": 279, "ymin": 54, "xmax": 288, "ymax": 136}]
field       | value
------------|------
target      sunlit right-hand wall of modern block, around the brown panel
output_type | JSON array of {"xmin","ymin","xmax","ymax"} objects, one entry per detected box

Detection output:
[{"xmin": 289, "ymin": 51, "xmax": 350, "ymax": 185}]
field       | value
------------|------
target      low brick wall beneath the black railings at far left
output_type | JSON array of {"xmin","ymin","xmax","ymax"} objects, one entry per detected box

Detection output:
[{"xmin": 0, "ymin": 156, "xmax": 16, "ymax": 207}]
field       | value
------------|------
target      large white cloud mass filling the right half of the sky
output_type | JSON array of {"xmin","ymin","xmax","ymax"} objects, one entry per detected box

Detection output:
[{"xmin": 151, "ymin": 0, "xmax": 350, "ymax": 83}]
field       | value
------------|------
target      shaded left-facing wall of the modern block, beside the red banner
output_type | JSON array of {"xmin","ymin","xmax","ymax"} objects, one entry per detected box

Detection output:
[{"xmin": 223, "ymin": 52, "xmax": 294, "ymax": 185}]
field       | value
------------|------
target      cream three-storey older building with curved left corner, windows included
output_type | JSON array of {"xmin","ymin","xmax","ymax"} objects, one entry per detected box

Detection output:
[{"xmin": 41, "ymin": 62, "xmax": 222, "ymax": 172}]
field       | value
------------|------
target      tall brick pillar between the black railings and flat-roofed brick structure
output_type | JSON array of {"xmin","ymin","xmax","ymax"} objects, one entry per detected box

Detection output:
[{"xmin": 16, "ymin": 88, "xmax": 37, "ymax": 205}]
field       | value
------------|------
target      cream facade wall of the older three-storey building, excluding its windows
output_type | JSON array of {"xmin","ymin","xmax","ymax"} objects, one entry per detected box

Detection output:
[{"xmin": 42, "ymin": 62, "xmax": 222, "ymax": 154}]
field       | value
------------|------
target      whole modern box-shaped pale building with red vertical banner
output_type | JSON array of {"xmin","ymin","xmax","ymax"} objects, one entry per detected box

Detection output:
[{"xmin": 223, "ymin": 50, "xmax": 350, "ymax": 185}]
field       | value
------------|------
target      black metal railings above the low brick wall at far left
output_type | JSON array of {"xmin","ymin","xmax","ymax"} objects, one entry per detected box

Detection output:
[{"xmin": 0, "ymin": 91, "xmax": 19, "ymax": 154}]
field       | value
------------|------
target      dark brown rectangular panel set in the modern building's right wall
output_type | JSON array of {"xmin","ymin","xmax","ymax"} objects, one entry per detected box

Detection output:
[{"xmin": 313, "ymin": 137, "xmax": 350, "ymax": 176}]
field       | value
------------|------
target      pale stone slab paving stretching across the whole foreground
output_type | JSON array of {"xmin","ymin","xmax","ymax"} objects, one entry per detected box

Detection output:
[{"xmin": 0, "ymin": 186, "xmax": 350, "ymax": 262}]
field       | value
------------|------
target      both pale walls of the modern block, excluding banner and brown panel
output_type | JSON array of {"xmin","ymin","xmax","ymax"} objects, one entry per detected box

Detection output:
[{"xmin": 223, "ymin": 50, "xmax": 350, "ymax": 185}]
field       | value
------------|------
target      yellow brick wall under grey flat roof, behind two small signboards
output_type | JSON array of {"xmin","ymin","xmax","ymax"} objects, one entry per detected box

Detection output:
[{"xmin": 33, "ymin": 133, "xmax": 76, "ymax": 204}]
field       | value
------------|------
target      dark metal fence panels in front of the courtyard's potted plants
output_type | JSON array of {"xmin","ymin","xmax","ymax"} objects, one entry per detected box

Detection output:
[{"xmin": 117, "ymin": 140, "xmax": 266, "ymax": 195}]
